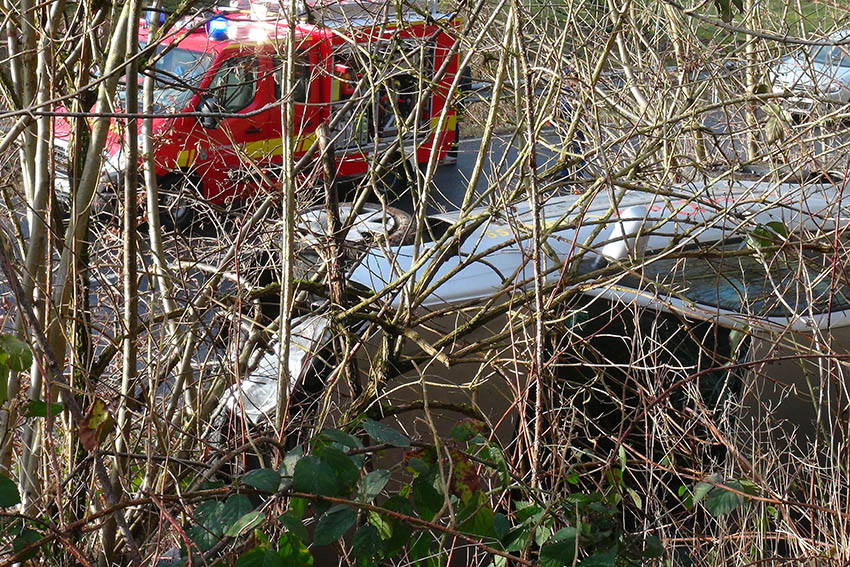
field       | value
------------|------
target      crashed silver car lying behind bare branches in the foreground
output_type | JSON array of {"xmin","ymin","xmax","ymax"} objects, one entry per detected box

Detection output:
[{"xmin": 223, "ymin": 180, "xmax": 850, "ymax": 450}]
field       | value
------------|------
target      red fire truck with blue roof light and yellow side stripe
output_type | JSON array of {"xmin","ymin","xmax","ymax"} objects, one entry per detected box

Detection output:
[{"xmin": 57, "ymin": 0, "xmax": 458, "ymax": 228}]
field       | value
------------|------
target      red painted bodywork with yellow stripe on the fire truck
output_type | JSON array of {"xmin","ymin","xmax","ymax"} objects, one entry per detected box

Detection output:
[{"xmin": 73, "ymin": 6, "xmax": 458, "ymax": 204}]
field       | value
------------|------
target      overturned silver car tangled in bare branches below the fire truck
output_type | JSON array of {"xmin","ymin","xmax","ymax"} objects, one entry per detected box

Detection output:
[{"xmin": 215, "ymin": 178, "xmax": 850, "ymax": 466}]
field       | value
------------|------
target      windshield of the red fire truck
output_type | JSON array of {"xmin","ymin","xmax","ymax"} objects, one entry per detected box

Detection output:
[{"xmin": 139, "ymin": 43, "xmax": 213, "ymax": 113}]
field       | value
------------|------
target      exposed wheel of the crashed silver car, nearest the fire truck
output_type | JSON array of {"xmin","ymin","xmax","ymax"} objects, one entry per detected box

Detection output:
[{"xmin": 295, "ymin": 202, "xmax": 412, "ymax": 246}]
